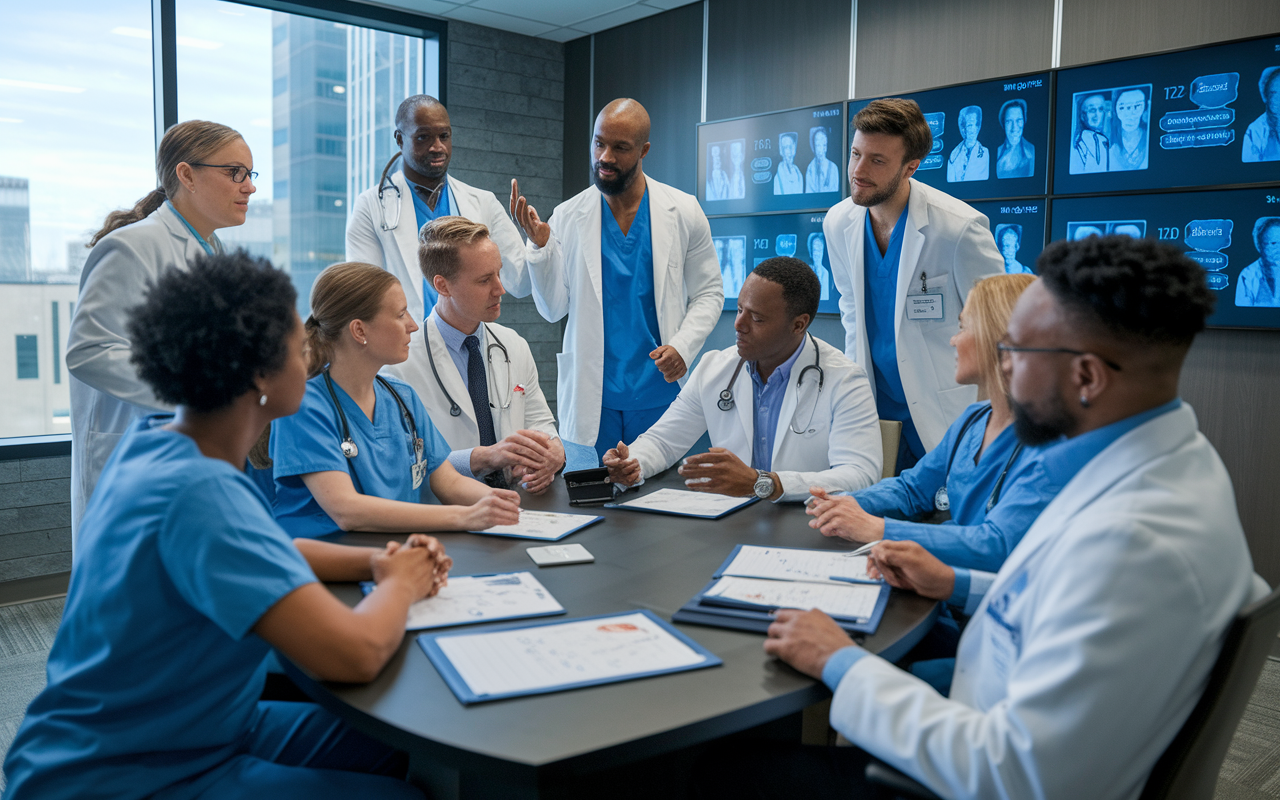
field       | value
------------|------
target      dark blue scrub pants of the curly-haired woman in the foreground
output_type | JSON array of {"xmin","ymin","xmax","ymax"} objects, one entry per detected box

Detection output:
[{"xmin": 154, "ymin": 701, "xmax": 424, "ymax": 800}]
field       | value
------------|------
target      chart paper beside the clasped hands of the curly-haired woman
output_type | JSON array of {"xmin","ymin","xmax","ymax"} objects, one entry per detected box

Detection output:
[{"xmin": 360, "ymin": 572, "xmax": 564, "ymax": 631}]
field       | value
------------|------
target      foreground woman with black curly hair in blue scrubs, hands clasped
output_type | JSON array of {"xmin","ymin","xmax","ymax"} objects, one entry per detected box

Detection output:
[{"xmin": 4, "ymin": 251, "xmax": 451, "ymax": 800}]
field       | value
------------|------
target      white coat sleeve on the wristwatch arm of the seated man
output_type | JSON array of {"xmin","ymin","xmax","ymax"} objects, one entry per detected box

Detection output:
[{"xmin": 777, "ymin": 365, "xmax": 884, "ymax": 503}]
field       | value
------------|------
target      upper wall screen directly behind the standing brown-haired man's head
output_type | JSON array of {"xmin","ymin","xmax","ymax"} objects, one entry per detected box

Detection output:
[{"xmin": 849, "ymin": 72, "xmax": 1050, "ymax": 200}]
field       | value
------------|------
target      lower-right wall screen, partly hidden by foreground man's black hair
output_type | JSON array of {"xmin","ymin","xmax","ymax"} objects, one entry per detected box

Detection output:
[{"xmin": 1050, "ymin": 188, "xmax": 1280, "ymax": 328}]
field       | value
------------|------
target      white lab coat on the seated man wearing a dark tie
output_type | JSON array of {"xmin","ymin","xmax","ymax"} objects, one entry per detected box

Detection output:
[{"xmin": 383, "ymin": 317, "xmax": 559, "ymax": 451}]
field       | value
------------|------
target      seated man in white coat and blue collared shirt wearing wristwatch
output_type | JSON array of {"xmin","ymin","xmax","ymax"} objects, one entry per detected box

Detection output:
[{"xmin": 604, "ymin": 256, "xmax": 883, "ymax": 500}]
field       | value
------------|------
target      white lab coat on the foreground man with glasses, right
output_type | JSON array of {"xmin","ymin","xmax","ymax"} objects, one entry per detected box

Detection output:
[{"xmin": 831, "ymin": 404, "xmax": 1267, "ymax": 799}]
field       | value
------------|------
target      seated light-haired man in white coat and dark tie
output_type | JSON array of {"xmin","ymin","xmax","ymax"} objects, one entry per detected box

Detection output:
[{"xmin": 387, "ymin": 216, "xmax": 564, "ymax": 494}]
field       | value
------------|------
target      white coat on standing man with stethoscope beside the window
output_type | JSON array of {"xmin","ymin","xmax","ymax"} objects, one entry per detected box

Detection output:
[{"xmin": 347, "ymin": 169, "xmax": 529, "ymax": 321}]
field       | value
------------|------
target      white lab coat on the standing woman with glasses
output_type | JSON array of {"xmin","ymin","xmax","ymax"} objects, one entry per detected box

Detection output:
[{"xmin": 67, "ymin": 204, "xmax": 205, "ymax": 536}]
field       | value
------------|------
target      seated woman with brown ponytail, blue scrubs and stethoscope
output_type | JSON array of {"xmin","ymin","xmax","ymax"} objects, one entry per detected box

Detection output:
[{"xmin": 270, "ymin": 261, "xmax": 520, "ymax": 538}]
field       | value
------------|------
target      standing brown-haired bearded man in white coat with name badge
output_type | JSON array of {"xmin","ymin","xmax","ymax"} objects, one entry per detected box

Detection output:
[{"xmin": 822, "ymin": 99, "xmax": 1005, "ymax": 471}]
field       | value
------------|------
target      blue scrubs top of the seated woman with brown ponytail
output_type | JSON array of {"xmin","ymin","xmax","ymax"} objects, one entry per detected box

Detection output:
[{"xmin": 271, "ymin": 374, "xmax": 449, "ymax": 539}]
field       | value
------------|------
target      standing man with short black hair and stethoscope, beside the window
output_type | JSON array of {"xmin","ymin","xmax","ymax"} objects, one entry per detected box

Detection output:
[{"xmin": 347, "ymin": 95, "xmax": 529, "ymax": 321}]
